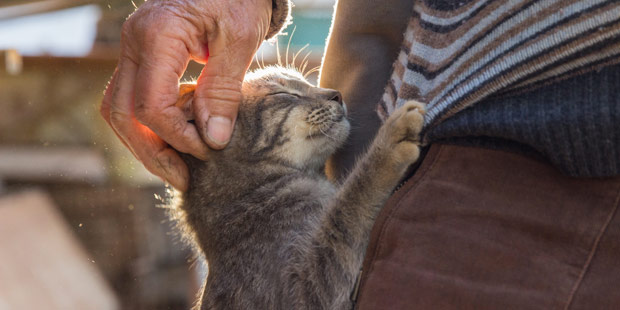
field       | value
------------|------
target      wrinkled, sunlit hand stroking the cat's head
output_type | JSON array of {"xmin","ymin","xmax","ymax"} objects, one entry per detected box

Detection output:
[{"xmin": 101, "ymin": 0, "xmax": 272, "ymax": 191}]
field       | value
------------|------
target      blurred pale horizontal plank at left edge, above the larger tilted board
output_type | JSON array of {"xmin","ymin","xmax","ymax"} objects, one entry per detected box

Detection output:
[{"xmin": 0, "ymin": 146, "xmax": 107, "ymax": 183}]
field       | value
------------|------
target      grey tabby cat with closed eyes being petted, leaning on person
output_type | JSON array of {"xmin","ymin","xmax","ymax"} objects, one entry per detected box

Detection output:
[{"xmin": 172, "ymin": 67, "xmax": 424, "ymax": 309}]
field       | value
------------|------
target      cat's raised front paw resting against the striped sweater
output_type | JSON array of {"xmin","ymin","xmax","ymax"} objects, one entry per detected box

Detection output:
[{"xmin": 379, "ymin": 100, "xmax": 426, "ymax": 165}]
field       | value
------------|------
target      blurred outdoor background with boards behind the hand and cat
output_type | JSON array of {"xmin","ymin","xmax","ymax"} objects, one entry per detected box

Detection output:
[{"xmin": 0, "ymin": 0, "xmax": 334, "ymax": 310}]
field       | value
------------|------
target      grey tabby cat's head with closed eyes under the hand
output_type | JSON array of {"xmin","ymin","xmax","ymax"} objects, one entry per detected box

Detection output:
[{"xmin": 178, "ymin": 67, "xmax": 349, "ymax": 169}]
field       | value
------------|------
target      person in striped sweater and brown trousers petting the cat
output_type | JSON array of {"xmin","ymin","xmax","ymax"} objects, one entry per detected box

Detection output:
[{"xmin": 101, "ymin": 0, "xmax": 620, "ymax": 309}]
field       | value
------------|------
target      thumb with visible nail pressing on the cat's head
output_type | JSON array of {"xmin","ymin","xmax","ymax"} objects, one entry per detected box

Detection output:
[{"xmin": 193, "ymin": 36, "xmax": 258, "ymax": 149}]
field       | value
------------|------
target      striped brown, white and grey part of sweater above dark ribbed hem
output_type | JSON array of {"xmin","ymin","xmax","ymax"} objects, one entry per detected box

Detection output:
[{"xmin": 379, "ymin": 0, "xmax": 620, "ymax": 127}]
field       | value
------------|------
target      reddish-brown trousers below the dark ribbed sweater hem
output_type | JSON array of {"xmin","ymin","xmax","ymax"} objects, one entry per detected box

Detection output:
[{"xmin": 356, "ymin": 145, "xmax": 620, "ymax": 310}]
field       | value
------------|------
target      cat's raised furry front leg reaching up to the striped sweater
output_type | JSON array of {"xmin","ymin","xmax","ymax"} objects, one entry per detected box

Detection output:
[{"xmin": 294, "ymin": 101, "xmax": 424, "ymax": 309}]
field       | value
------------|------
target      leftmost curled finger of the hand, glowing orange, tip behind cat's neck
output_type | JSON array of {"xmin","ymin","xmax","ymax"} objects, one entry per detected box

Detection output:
[{"xmin": 109, "ymin": 57, "xmax": 189, "ymax": 191}]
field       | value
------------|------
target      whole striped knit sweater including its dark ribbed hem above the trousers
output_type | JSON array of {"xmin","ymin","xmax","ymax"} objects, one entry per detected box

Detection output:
[{"xmin": 274, "ymin": 0, "xmax": 620, "ymax": 176}]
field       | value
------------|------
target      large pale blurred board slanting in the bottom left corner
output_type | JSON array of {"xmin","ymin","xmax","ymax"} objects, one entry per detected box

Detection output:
[{"xmin": 0, "ymin": 191, "xmax": 119, "ymax": 310}]
